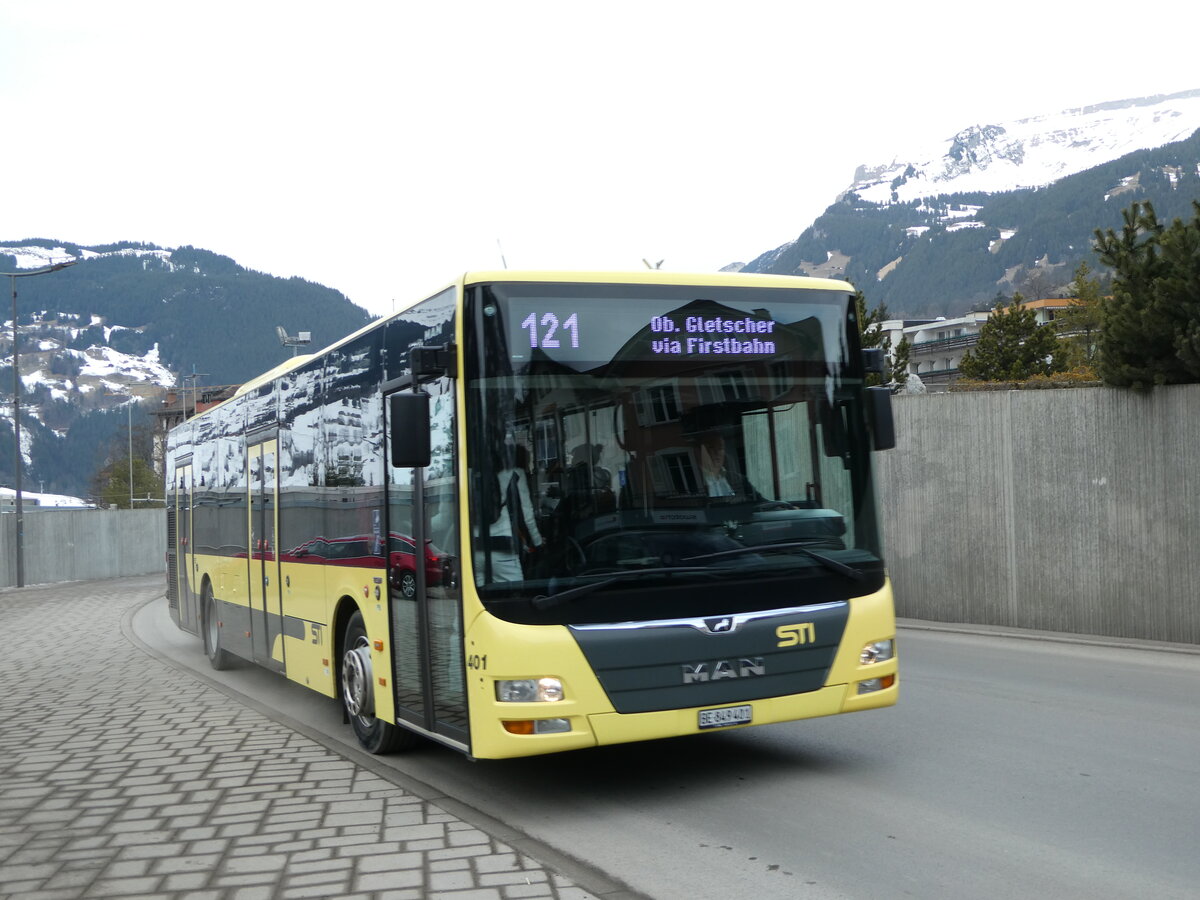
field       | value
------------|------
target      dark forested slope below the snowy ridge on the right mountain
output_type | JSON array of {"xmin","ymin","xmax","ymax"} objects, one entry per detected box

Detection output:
[{"xmin": 744, "ymin": 131, "xmax": 1200, "ymax": 318}]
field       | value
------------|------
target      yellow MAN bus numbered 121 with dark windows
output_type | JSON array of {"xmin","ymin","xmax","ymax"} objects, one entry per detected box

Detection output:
[{"xmin": 167, "ymin": 270, "xmax": 898, "ymax": 758}]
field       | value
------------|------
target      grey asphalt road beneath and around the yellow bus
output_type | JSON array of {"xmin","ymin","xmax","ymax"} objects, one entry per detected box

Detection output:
[{"xmin": 134, "ymin": 602, "xmax": 1200, "ymax": 900}]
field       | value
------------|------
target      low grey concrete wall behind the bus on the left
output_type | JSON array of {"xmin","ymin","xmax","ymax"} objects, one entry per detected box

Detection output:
[{"xmin": 0, "ymin": 509, "xmax": 167, "ymax": 589}]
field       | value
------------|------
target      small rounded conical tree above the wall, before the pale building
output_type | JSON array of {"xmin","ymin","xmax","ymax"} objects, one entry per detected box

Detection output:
[{"xmin": 959, "ymin": 294, "xmax": 1066, "ymax": 382}]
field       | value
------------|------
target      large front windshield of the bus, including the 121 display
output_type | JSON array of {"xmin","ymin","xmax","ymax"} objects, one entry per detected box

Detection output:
[{"xmin": 464, "ymin": 282, "xmax": 883, "ymax": 624}]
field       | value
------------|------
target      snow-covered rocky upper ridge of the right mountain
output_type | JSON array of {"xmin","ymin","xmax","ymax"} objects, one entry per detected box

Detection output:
[{"xmin": 847, "ymin": 90, "xmax": 1200, "ymax": 204}]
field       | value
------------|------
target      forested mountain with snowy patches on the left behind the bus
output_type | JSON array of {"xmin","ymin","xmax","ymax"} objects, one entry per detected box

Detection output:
[{"xmin": 0, "ymin": 239, "xmax": 371, "ymax": 497}]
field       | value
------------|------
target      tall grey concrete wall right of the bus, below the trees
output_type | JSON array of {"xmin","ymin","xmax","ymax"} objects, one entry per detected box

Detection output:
[{"xmin": 876, "ymin": 385, "xmax": 1200, "ymax": 643}]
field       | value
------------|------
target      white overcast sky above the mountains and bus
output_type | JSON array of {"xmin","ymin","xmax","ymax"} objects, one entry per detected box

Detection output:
[{"xmin": 0, "ymin": 0, "xmax": 1200, "ymax": 319}]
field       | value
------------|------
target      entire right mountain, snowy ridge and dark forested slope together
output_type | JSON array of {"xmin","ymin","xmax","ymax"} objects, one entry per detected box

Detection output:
[{"xmin": 743, "ymin": 90, "xmax": 1200, "ymax": 318}]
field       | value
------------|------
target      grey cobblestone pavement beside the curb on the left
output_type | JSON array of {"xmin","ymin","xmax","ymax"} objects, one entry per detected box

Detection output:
[{"xmin": 0, "ymin": 577, "xmax": 629, "ymax": 900}]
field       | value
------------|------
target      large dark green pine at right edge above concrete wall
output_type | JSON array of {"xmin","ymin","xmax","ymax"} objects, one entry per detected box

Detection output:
[{"xmin": 1096, "ymin": 202, "xmax": 1200, "ymax": 390}]
